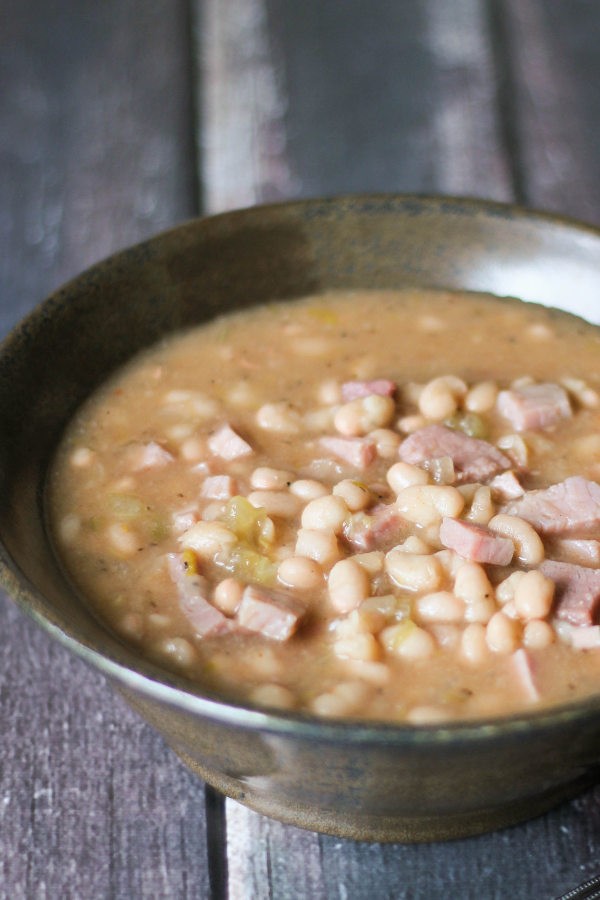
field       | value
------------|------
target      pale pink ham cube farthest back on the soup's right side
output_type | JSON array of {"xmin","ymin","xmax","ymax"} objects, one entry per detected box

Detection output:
[{"xmin": 497, "ymin": 383, "xmax": 572, "ymax": 431}]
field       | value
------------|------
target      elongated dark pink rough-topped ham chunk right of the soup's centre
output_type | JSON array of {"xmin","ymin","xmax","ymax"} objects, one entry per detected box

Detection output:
[{"xmin": 399, "ymin": 425, "xmax": 512, "ymax": 481}]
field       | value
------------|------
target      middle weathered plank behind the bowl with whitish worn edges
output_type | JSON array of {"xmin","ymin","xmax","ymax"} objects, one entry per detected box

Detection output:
[{"xmin": 197, "ymin": 0, "xmax": 511, "ymax": 211}]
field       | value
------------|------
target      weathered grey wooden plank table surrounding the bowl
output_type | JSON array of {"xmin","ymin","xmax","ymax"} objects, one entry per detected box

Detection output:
[{"xmin": 0, "ymin": 0, "xmax": 600, "ymax": 900}]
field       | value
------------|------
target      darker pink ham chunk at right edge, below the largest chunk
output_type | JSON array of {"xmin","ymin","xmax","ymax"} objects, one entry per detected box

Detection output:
[{"xmin": 540, "ymin": 559, "xmax": 600, "ymax": 625}]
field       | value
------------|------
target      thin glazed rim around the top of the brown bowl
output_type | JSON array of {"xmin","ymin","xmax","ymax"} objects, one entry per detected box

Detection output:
[{"xmin": 0, "ymin": 192, "xmax": 600, "ymax": 749}]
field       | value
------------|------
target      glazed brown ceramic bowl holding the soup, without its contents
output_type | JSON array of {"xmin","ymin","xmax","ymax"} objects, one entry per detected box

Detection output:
[{"xmin": 0, "ymin": 196, "xmax": 600, "ymax": 841}]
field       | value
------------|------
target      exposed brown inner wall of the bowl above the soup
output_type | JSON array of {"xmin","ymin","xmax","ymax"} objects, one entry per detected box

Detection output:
[{"xmin": 0, "ymin": 196, "xmax": 600, "ymax": 716}]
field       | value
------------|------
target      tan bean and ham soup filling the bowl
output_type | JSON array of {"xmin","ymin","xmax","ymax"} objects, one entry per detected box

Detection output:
[{"xmin": 49, "ymin": 290, "xmax": 600, "ymax": 723}]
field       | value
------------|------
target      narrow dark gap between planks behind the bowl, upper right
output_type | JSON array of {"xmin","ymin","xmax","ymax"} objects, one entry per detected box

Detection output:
[{"xmin": 486, "ymin": 0, "xmax": 529, "ymax": 203}]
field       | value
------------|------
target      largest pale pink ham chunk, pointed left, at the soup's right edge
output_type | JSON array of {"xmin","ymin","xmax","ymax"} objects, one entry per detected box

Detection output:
[{"xmin": 504, "ymin": 475, "xmax": 600, "ymax": 535}]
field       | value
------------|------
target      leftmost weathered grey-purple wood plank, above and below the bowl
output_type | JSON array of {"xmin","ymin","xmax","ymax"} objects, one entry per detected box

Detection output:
[{"xmin": 0, "ymin": 0, "xmax": 209, "ymax": 900}]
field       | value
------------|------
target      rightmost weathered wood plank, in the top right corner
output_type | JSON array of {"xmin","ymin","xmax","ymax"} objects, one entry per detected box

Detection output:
[{"xmin": 503, "ymin": 0, "xmax": 600, "ymax": 224}]
